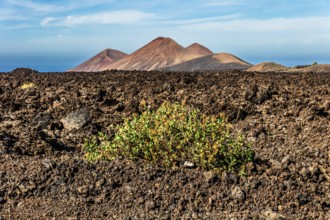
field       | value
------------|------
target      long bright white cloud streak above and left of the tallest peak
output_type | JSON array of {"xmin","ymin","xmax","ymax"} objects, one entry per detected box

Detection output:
[{"xmin": 41, "ymin": 10, "xmax": 154, "ymax": 26}]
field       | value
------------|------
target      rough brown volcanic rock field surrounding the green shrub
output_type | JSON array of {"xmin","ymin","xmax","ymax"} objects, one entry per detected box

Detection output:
[{"xmin": 0, "ymin": 69, "xmax": 330, "ymax": 219}]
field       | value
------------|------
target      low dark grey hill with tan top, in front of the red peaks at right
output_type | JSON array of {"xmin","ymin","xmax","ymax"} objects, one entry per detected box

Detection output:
[{"xmin": 160, "ymin": 53, "xmax": 252, "ymax": 72}]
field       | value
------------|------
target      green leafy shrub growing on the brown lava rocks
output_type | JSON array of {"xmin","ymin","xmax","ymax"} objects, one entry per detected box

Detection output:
[{"xmin": 84, "ymin": 102, "xmax": 254, "ymax": 173}]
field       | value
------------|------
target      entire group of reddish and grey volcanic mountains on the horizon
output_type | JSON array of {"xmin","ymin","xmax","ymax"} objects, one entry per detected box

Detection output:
[{"xmin": 67, "ymin": 37, "xmax": 252, "ymax": 71}]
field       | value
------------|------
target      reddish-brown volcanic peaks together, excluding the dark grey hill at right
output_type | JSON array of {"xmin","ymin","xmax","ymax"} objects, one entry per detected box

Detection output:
[{"xmin": 68, "ymin": 37, "xmax": 213, "ymax": 72}]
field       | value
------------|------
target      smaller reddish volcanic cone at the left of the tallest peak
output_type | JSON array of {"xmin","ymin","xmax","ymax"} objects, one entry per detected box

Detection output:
[{"xmin": 68, "ymin": 49, "xmax": 127, "ymax": 72}]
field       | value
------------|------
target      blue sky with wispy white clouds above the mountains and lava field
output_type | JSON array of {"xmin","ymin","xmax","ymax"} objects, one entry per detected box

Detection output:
[{"xmin": 0, "ymin": 0, "xmax": 330, "ymax": 71}]
